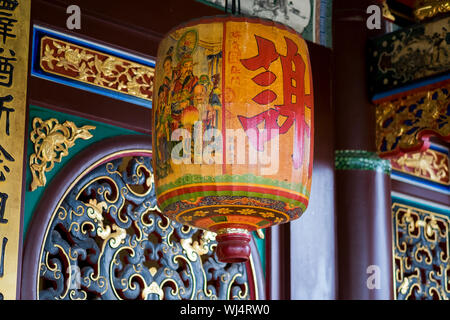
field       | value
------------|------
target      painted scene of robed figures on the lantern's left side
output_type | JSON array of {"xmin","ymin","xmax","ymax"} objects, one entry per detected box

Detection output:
[{"xmin": 154, "ymin": 29, "xmax": 222, "ymax": 178}]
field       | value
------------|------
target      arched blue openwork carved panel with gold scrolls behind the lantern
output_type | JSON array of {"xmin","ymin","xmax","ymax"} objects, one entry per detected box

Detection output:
[{"xmin": 38, "ymin": 156, "xmax": 253, "ymax": 300}]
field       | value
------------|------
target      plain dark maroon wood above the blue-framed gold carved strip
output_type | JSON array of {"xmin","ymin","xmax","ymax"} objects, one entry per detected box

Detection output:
[{"xmin": 32, "ymin": 0, "xmax": 223, "ymax": 56}]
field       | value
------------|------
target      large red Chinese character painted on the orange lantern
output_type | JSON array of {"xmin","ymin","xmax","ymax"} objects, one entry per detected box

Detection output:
[{"xmin": 238, "ymin": 35, "xmax": 312, "ymax": 169}]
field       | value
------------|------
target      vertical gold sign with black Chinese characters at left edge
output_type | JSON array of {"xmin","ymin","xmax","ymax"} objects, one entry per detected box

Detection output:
[{"xmin": 0, "ymin": 0, "xmax": 31, "ymax": 300}]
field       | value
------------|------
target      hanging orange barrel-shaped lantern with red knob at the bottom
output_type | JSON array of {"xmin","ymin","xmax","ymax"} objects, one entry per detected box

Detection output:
[{"xmin": 153, "ymin": 17, "xmax": 314, "ymax": 262}]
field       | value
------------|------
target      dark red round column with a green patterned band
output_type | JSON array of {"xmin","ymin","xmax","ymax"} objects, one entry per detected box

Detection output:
[{"xmin": 333, "ymin": 0, "xmax": 393, "ymax": 299}]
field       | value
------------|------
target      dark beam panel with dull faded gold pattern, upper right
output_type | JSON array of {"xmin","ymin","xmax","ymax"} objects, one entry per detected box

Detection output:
[{"xmin": 367, "ymin": 17, "xmax": 450, "ymax": 95}]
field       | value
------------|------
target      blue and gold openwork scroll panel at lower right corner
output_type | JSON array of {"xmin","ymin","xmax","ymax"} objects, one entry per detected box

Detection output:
[{"xmin": 392, "ymin": 203, "xmax": 450, "ymax": 300}]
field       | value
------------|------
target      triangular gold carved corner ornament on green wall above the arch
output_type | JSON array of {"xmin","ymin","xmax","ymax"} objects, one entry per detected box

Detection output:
[{"xmin": 29, "ymin": 118, "xmax": 95, "ymax": 191}]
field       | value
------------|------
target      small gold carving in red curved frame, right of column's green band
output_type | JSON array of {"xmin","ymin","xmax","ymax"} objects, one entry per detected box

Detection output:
[{"xmin": 391, "ymin": 149, "xmax": 450, "ymax": 185}]
